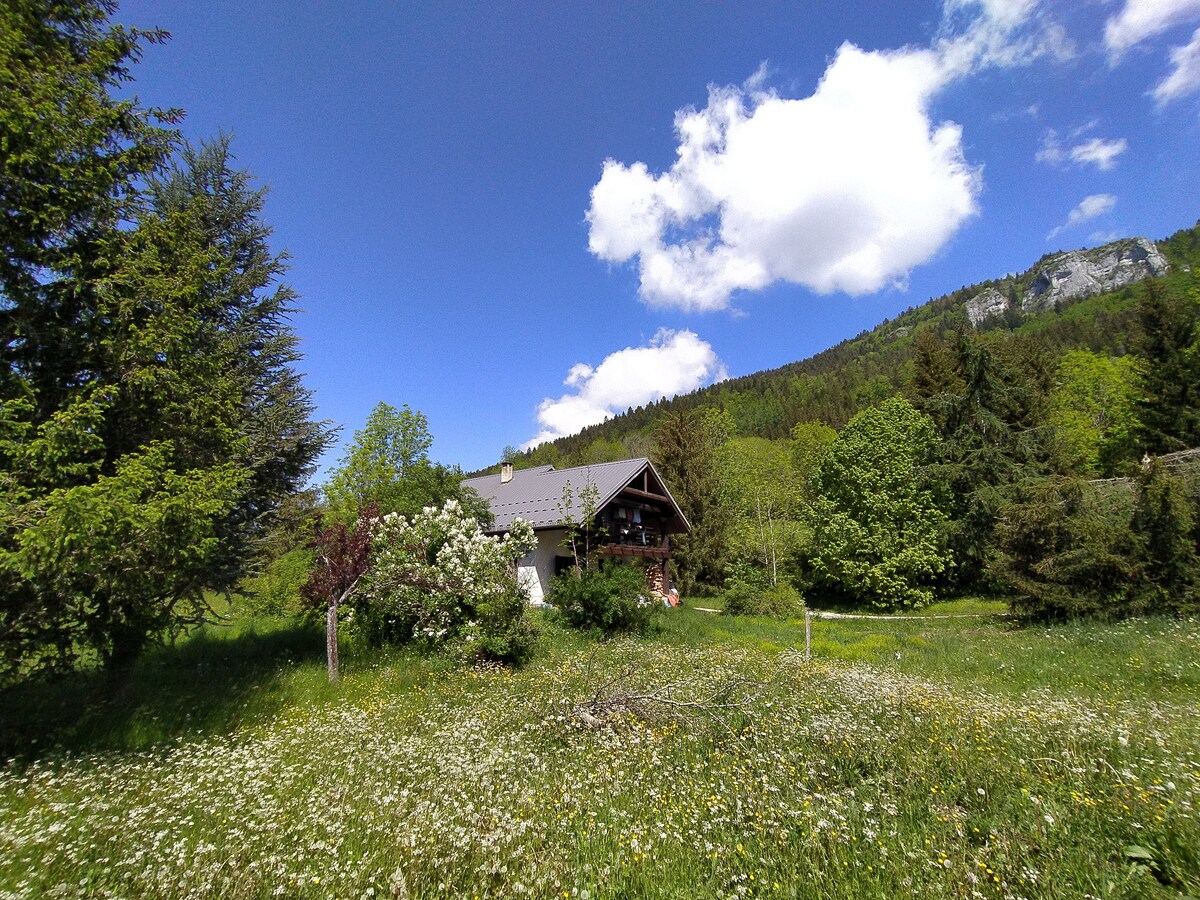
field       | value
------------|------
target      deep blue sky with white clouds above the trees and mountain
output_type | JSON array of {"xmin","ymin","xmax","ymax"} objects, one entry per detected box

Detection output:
[{"xmin": 118, "ymin": 0, "xmax": 1200, "ymax": 469}]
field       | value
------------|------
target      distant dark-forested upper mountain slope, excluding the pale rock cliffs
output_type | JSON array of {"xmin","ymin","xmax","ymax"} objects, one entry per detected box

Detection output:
[{"xmin": 497, "ymin": 223, "xmax": 1200, "ymax": 468}]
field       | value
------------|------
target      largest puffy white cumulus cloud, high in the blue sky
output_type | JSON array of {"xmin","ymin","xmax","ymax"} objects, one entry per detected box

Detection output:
[{"xmin": 587, "ymin": 0, "xmax": 1064, "ymax": 311}]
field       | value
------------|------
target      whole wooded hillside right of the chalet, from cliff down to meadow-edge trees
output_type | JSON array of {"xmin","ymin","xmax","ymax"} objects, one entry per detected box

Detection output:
[{"xmin": 470, "ymin": 224, "xmax": 1200, "ymax": 618}]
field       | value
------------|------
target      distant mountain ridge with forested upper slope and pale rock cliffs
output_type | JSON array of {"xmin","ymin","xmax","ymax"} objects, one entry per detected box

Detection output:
[{"xmin": 470, "ymin": 221, "xmax": 1200, "ymax": 475}]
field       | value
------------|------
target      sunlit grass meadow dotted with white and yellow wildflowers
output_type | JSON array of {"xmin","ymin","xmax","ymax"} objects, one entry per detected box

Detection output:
[{"xmin": 0, "ymin": 602, "xmax": 1200, "ymax": 900}]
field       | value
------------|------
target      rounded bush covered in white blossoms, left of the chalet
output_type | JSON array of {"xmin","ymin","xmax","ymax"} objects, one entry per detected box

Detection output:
[{"xmin": 355, "ymin": 500, "xmax": 534, "ymax": 661}]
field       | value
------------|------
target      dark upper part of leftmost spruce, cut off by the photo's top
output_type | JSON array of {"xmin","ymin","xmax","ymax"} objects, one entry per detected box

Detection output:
[{"xmin": 0, "ymin": 0, "xmax": 176, "ymax": 422}]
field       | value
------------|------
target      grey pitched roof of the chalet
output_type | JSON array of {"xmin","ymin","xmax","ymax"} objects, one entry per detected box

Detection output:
[{"xmin": 462, "ymin": 456, "xmax": 690, "ymax": 532}]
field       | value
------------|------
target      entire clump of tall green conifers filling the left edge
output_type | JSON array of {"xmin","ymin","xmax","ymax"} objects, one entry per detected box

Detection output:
[{"xmin": 0, "ymin": 0, "xmax": 326, "ymax": 677}]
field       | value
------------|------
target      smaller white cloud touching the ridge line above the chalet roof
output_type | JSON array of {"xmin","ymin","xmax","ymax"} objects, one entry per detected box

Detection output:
[{"xmin": 524, "ymin": 329, "xmax": 727, "ymax": 450}]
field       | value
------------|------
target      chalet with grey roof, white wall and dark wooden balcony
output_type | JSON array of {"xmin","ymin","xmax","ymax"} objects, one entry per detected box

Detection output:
[{"xmin": 463, "ymin": 457, "xmax": 691, "ymax": 604}]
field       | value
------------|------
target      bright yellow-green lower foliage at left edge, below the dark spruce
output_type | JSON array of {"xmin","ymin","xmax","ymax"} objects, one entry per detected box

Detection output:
[{"xmin": 0, "ymin": 443, "xmax": 245, "ymax": 673}]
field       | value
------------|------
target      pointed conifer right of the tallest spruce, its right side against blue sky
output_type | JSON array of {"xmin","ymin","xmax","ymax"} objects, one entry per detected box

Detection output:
[{"xmin": 129, "ymin": 138, "xmax": 330, "ymax": 589}]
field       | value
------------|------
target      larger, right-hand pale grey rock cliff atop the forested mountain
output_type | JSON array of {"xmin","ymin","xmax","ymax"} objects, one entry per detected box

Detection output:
[{"xmin": 1017, "ymin": 238, "xmax": 1169, "ymax": 322}]
